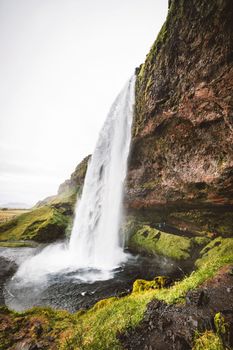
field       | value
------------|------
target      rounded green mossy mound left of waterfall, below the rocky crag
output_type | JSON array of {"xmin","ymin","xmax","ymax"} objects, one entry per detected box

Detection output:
[{"xmin": 0, "ymin": 206, "xmax": 69, "ymax": 242}]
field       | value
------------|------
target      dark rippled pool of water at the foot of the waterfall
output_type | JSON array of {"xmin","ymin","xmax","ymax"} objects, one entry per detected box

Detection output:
[{"xmin": 0, "ymin": 247, "xmax": 187, "ymax": 312}]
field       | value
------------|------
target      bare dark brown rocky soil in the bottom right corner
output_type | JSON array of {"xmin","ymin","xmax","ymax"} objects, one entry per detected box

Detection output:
[{"xmin": 120, "ymin": 267, "xmax": 233, "ymax": 350}]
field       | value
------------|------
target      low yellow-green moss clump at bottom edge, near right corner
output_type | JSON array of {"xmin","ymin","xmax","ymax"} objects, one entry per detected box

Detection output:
[{"xmin": 192, "ymin": 331, "xmax": 225, "ymax": 350}]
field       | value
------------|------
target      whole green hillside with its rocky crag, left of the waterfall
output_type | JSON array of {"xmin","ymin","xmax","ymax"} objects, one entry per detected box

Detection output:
[{"xmin": 0, "ymin": 156, "xmax": 90, "ymax": 245}]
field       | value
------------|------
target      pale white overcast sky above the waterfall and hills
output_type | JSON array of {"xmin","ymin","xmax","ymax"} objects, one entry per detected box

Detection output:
[{"xmin": 0, "ymin": 0, "xmax": 168, "ymax": 205}]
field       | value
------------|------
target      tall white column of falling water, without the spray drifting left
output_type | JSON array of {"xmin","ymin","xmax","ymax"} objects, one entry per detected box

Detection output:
[{"xmin": 69, "ymin": 77, "xmax": 135, "ymax": 269}]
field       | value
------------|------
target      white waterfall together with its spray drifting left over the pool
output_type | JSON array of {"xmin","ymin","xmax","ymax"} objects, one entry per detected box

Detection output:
[{"xmin": 5, "ymin": 77, "xmax": 135, "ymax": 300}]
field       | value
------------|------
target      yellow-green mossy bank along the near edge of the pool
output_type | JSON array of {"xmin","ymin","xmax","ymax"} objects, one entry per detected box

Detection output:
[{"xmin": 0, "ymin": 238, "xmax": 233, "ymax": 350}]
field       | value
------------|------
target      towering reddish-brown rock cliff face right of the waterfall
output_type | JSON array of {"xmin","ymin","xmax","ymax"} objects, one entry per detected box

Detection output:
[{"xmin": 126, "ymin": 0, "xmax": 233, "ymax": 235}]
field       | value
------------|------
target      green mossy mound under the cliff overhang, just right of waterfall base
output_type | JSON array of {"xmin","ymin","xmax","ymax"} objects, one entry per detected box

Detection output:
[{"xmin": 129, "ymin": 225, "xmax": 192, "ymax": 260}]
